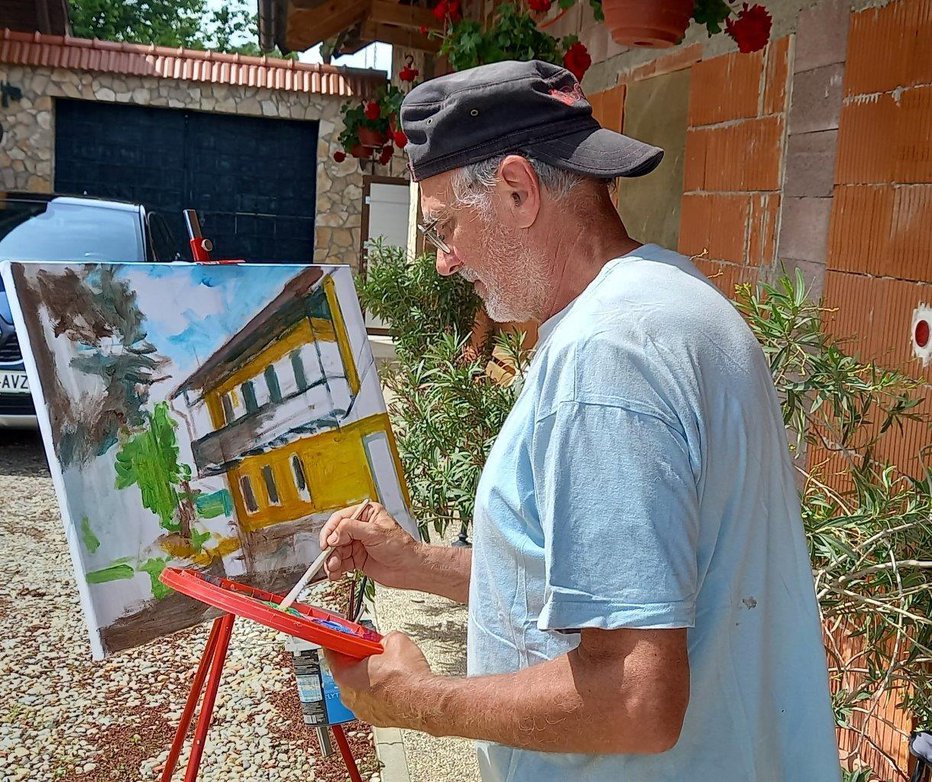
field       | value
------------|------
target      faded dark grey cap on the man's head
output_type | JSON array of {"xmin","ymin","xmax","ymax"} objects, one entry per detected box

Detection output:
[{"xmin": 401, "ymin": 60, "xmax": 663, "ymax": 181}]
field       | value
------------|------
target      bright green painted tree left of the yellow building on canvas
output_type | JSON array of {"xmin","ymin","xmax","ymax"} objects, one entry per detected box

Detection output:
[{"xmin": 114, "ymin": 402, "xmax": 197, "ymax": 543}]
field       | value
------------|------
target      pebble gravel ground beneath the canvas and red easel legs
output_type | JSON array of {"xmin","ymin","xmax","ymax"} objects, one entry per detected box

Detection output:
[{"xmin": 0, "ymin": 431, "xmax": 380, "ymax": 782}]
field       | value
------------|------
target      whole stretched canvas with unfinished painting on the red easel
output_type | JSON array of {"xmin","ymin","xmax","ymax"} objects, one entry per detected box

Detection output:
[{"xmin": 2, "ymin": 262, "xmax": 416, "ymax": 658}]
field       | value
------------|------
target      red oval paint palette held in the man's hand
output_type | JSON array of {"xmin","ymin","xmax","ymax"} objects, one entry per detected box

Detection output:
[{"xmin": 159, "ymin": 567, "xmax": 384, "ymax": 660}]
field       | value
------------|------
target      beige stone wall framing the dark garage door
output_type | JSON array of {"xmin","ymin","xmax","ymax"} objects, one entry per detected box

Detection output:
[{"xmin": 0, "ymin": 64, "xmax": 362, "ymax": 268}]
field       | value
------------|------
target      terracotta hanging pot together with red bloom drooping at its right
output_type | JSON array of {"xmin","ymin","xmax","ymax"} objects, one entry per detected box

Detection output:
[{"xmin": 602, "ymin": 0, "xmax": 772, "ymax": 52}]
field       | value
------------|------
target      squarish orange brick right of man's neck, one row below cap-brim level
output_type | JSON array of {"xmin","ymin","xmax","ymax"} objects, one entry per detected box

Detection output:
[{"xmin": 678, "ymin": 193, "xmax": 750, "ymax": 263}]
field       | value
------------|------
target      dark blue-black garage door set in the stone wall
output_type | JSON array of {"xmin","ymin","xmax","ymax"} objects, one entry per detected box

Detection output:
[{"xmin": 55, "ymin": 100, "xmax": 317, "ymax": 262}]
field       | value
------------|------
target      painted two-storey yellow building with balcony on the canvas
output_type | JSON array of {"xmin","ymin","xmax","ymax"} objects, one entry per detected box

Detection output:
[{"xmin": 172, "ymin": 267, "xmax": 414, "ymax": 588}]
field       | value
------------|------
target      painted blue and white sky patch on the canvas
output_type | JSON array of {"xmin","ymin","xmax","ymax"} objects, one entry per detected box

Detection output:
[{"xmin": 120, "ymin": 264, "xmax": 304, "ymax": 393}]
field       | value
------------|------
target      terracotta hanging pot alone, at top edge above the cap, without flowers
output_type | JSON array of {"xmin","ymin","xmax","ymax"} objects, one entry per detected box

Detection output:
[{"xmin": 602, "ymin": 0, "xmax": 694, "ymax": 49}]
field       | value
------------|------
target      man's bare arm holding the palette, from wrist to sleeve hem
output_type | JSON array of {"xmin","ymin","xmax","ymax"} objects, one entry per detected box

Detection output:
[{"xmin": 386, "ymin": 636, "xmax": 688, "ymax": 754}]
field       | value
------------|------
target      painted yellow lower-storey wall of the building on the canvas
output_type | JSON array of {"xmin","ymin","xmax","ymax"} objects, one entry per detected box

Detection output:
[{"xmin": 227, "ymin": 413, "xmax": 408, "ymax": 530}]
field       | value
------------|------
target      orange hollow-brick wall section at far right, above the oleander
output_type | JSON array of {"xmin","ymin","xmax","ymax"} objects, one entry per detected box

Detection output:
[{"xmin": 825, "ymin": 0, "xmax": 932, "ymax": 484}]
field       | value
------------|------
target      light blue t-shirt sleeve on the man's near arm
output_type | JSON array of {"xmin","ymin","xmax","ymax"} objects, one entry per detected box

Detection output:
[{"xmin": 533, "ymin": 401, "xmax": 699, "ymax": 630}]
